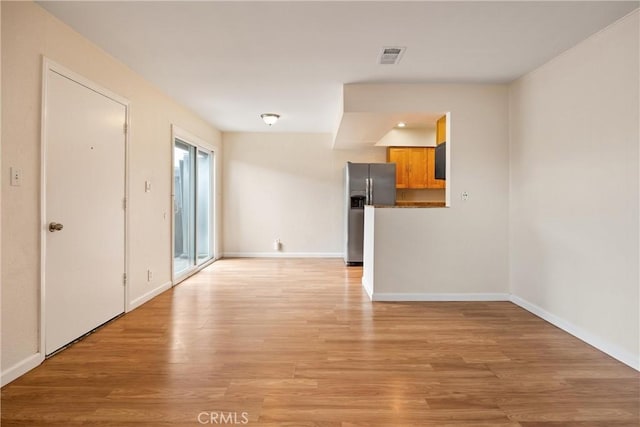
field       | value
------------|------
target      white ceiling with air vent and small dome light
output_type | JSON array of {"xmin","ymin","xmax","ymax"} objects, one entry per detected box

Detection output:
[{"xmin": 39, "ymin": 1, "xmax": 639, "ymax": 133}]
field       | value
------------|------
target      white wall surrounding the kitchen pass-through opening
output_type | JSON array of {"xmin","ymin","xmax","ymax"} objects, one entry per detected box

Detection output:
[{"xmin": 344, "ymin": 84, "xmax": 509, "ymax": 299}]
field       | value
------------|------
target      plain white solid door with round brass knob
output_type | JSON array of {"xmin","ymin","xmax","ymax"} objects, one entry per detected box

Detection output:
[{"xmin": 43, "ymin": 70, "xmax": 127, "ymax": 354}]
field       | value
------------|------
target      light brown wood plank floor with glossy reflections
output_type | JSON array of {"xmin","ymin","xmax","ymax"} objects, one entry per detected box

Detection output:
[{"xmin": 2, "ymin": 259, "xmax": 640, "ymax": 427}]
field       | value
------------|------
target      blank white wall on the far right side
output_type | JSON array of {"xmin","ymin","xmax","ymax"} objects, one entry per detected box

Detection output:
[{"xmin": 510, "ymin": 11, "xmax": 640, "ymax": 368}]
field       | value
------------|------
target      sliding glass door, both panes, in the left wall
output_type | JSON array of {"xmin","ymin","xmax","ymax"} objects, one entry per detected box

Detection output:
[{"xmin": 173, "ymin": 138, "xmax": 213, "ymax": 280}]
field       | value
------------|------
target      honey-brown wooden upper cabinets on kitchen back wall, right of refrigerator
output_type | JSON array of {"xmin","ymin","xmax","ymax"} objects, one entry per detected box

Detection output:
[{"xmin": 387, "ymin": 147, "xmax": 445, "ymax": 189}]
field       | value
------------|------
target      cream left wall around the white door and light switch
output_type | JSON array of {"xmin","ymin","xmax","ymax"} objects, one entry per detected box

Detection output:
[{"xmin": 1, "ymin": 2, "xmax": 221, "ymax": 382}]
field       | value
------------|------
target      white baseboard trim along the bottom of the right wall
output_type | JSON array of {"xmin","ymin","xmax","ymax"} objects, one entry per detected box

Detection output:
[{"xmin": 511, "ymin": 295, "xmax": 640, "ymax": 371}]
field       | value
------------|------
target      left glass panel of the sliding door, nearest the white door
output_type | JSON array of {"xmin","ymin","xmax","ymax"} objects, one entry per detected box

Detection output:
[{"xmin": 173, "ymin": 139, "xmax": 195, "ymax": 276}]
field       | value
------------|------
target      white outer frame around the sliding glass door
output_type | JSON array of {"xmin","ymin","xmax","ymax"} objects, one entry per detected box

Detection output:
[{"xmin": 169, "ymin": 124, "xmax": 219, "ymax": 286}]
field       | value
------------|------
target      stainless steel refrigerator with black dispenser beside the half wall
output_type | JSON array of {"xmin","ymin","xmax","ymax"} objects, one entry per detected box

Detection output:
[{"xmin": 344, "ymin": 162, "xmax": 396, "ymax": 265}]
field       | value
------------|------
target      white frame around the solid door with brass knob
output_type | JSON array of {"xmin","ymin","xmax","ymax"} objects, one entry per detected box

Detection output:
[{"xmin": 38, "ymin": 56, "xmax": 131, "ymax": 363}]
